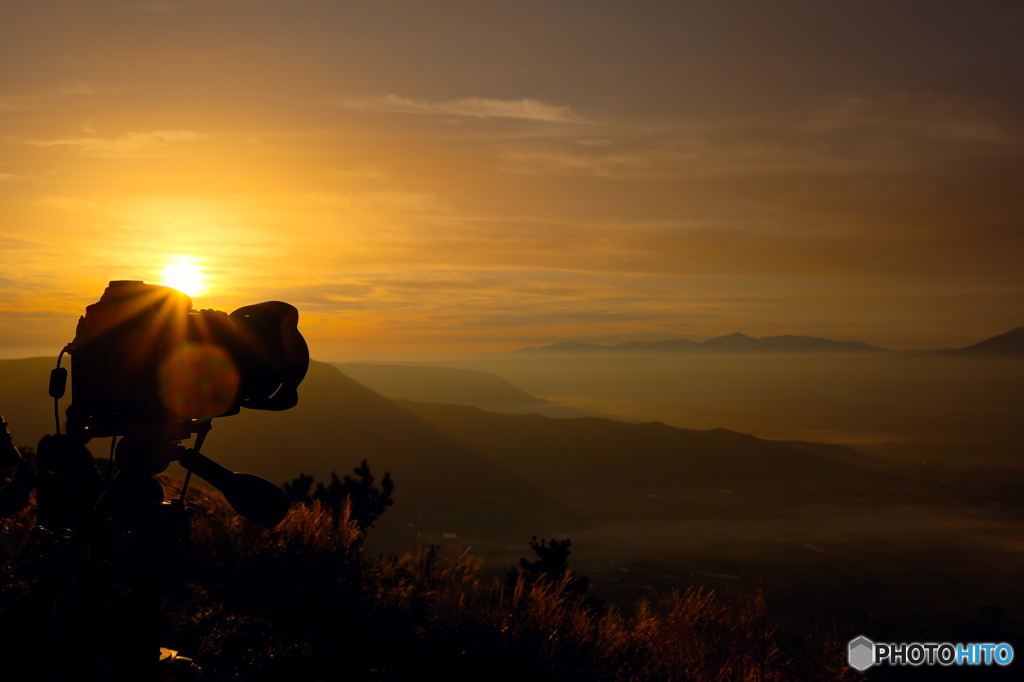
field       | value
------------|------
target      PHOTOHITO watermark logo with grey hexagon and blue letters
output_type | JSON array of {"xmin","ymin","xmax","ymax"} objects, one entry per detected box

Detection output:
[{"xmin": 847, "ymin": 635, "xmax": 1014, "ymax": 671}]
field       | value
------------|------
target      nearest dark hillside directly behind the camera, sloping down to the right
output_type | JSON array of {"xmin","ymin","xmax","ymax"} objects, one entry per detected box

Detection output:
[{"xmin": 0, "ymin": 358, "xmax": 567, "ymax": 538}]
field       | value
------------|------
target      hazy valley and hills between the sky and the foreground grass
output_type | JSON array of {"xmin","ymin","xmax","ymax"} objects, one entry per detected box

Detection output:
[{"xmin": 0, "ymin": 329, "xmax": 1024, "ymax": 647}]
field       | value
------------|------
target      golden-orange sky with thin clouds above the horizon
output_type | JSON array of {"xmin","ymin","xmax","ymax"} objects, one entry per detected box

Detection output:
[{"xmin": 0, "ymin": 0, "xmax": 1024, "ymax": 359}]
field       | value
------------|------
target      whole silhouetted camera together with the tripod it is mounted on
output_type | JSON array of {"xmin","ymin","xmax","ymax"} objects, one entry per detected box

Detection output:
[{"xmin": 0, "ymin": 281, "xmax": 309, "ymax": 680}]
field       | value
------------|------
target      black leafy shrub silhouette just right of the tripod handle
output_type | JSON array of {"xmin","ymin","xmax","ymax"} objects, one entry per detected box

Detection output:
[{"xmin": 283, "ymin": 460, "xmax": 394, "ymax": 530}]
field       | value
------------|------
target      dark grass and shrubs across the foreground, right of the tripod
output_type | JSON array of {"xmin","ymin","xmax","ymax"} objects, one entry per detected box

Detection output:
[{"xmin": 0, "ymin": 462, "xmax": 849, "ymax": 682}]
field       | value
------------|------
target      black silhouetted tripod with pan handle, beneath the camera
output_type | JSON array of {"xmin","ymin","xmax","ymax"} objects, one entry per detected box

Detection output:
[{"xmin": 5, "ymin": 422, "xmax": 290, "ymax": 682}]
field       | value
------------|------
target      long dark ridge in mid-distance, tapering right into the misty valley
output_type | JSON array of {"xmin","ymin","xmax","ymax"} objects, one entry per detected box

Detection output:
[{"xmin": 399, "ymin": 401, "xmax": 898, "ymax": 520}]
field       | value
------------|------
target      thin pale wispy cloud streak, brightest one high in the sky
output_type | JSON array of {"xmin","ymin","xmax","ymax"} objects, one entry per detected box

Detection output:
[{"xmin": 336, "ymin": 94, "xmax": 586, "ymax": 123}]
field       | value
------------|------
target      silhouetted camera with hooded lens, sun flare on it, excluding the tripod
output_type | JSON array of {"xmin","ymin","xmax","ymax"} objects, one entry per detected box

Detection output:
[{"xmin": 67, "ymin": 281, "xmax": 309, "ymax": 440}]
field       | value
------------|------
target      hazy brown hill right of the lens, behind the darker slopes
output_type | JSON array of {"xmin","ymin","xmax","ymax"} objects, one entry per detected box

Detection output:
[{"xmin": 334, "ymin": 363, "xmax": 585, "ymax": 417}]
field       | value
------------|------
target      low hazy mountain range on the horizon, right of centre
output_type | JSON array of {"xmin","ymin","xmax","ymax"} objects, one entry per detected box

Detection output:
[{"xmin": 516, "ymin": 333, "xmax": 892, "ymax": 354}]
